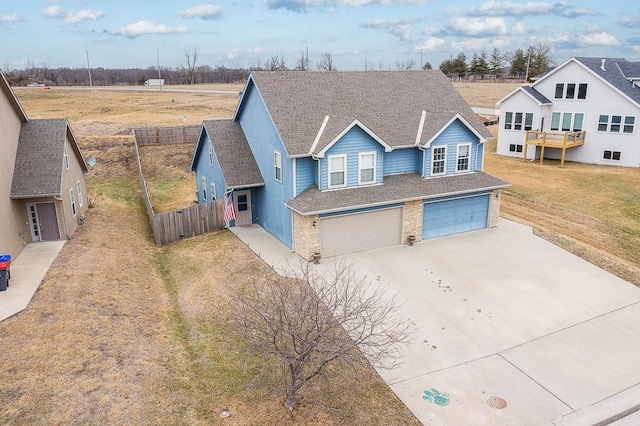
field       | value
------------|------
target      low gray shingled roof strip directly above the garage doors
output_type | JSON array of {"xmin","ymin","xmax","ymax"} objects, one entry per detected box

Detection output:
[{"xmin": 287, "ymin": 172, "xmax": 510, "ymax": 215}]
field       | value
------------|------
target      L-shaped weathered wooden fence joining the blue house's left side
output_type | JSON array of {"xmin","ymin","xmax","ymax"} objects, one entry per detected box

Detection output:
[{"xmin": 135, "ymin": 128, "xmax": 225, "ymax": 246}]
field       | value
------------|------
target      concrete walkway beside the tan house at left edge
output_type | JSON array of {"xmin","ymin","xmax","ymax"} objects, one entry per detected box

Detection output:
[{"xmin": 0, "ymin": 240, "xmax": 65, "ymax": 321}]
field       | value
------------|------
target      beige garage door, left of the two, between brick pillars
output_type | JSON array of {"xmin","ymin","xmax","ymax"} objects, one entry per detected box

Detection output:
[{"xmin": 320, "ymin": 207, "xmax": 403, "ymax": 257}]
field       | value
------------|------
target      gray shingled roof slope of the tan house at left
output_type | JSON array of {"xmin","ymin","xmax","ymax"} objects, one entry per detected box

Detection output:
[{"xmin": 11, "ymin": 118, "xmax": 70, "ymax": 198}]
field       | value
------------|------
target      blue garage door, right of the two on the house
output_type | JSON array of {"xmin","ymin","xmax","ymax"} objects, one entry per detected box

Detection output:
[{"xmin": 422, "ymin": 195, "xmax": 489, "ymax": 239}]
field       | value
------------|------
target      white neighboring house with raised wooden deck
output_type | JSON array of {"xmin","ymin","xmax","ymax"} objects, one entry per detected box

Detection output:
[{"xmin": 497, "ymin": 57, "xmax": 640, "ymax": 167}]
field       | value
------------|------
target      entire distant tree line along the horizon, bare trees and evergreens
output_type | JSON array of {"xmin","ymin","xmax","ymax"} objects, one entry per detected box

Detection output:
[{"xmin": 3, "ymin": 44, "xmax": 552, "ymax": 86}]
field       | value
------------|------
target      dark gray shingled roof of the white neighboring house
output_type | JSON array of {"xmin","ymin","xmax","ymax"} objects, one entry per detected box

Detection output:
[{"xmin": 575, "ymin": 57, "xmax": 640, "ymax": 104}]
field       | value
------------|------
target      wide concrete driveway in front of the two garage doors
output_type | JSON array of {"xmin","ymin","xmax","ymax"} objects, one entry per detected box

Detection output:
[{"xmin": 348, "ymin": 219, "xmax": 640, "ymax": 425}]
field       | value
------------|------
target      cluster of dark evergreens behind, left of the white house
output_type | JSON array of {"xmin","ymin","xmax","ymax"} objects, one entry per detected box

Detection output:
[{"xmin": 440, "ymin": 44, "xmax": 553, "ymax": 80}]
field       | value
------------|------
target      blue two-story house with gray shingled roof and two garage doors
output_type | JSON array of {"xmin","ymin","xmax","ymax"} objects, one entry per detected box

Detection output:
[{"xmin": 191, "ymin": 71, "xmax": 508, "ymax": 260}]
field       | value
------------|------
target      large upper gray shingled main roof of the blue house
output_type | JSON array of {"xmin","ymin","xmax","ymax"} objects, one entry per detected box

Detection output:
[{"xmin": 244, "ymin": 70, "xmax": 492, "ymax": 156}]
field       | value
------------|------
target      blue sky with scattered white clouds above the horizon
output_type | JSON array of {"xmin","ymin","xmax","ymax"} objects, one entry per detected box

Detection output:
[{"xmin": 0, "ymin": 0, "xmax": 640, "ymax": 70}]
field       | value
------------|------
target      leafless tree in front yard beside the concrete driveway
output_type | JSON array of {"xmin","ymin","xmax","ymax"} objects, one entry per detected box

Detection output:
[{"xmin": 230, "ymin": 261, "xmax": 410, "ymax": 411}]
